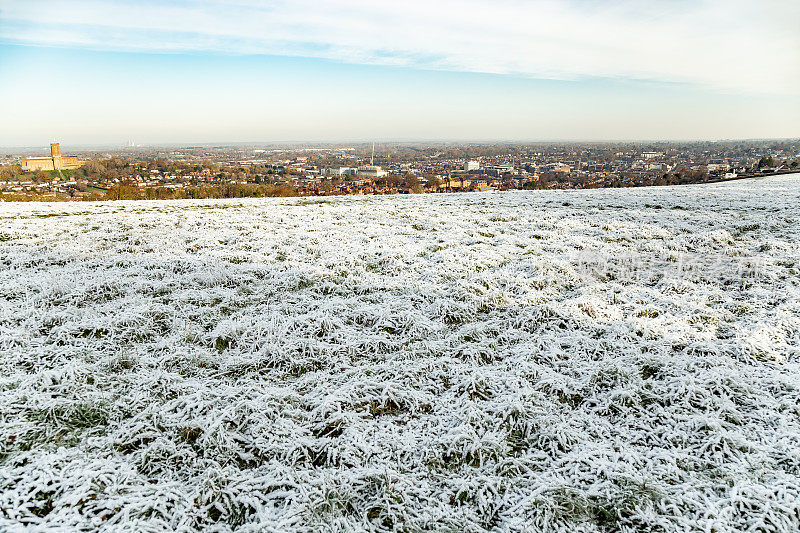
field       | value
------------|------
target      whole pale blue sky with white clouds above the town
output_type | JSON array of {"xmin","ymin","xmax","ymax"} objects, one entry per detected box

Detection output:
[{"xmin": 0, "ymin": 0, "xmax": 800, "ymax": 146}]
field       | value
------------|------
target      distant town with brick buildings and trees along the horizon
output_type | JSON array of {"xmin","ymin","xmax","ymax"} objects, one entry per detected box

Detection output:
[{"xmin": 0, "ymin": 140, "xmax": 800, "ymax": 201}]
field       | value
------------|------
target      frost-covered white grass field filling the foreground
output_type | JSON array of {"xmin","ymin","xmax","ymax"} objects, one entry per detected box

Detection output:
[{"xmin": 0, "ymin": 176, "xmax": 800, "ymax": 532}]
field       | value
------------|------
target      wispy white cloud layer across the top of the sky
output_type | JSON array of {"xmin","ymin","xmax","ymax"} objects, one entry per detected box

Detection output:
[{"xmin": 0, "ymin": 0, "xmax": 800, "ymax": 94}]
